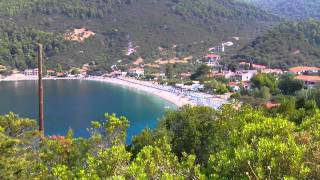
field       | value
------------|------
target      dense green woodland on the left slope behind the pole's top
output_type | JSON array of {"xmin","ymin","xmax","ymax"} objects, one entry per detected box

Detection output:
[{"xmin": 0, "ymin": 21, "xmax": 70, "ymax": 69}]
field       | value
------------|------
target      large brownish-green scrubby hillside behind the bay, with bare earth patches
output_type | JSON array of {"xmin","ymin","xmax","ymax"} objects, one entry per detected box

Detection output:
[{"xmin": 0, "ymin": 0, "xmax": 280, "ymax": 68}]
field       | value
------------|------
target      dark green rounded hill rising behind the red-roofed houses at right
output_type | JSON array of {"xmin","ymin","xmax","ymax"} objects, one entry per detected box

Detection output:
[{"xmin": 233, "ymin": 20, "xmax": 320, "ymax": 68}]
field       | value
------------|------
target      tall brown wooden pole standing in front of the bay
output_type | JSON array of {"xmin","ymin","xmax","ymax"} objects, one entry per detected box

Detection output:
[{"xmin": 38, "ymin": 44, "xmax": 44, "ymax": 135}]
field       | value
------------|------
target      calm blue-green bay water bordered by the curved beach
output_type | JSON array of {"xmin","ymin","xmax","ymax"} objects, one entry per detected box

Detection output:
[{"xmin": 0, "ymin": 80, "xmax": 176, "ymax": 142}]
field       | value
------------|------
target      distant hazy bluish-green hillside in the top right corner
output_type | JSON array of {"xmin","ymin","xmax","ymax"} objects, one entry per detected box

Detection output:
[{"xmin": 239, "ymin": 0, "xmax": 320, "ymax": 19}]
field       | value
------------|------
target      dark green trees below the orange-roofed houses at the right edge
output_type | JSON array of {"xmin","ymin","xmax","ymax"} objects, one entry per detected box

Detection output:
[{"xmin": 232, "ymin": 73, "xmax": 320, "ymax": 124}]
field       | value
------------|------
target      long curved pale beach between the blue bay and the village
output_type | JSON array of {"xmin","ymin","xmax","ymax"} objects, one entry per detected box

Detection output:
[{"xmin": 0, "ymin": 76, "xmax": 229, "ymax": 109}]
